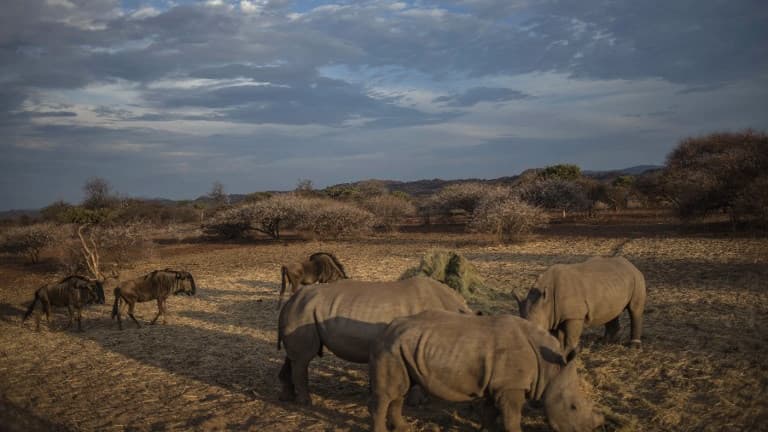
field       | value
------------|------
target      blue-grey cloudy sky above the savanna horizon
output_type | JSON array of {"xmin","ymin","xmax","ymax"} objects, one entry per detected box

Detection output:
[{"xmin": 0, "ymin": 0, "xmax": 768, "ymax": 210}]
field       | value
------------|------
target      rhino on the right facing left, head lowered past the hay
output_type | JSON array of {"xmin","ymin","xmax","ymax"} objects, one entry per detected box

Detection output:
[{"xmin": 513, "ymin": 257, "xmax": 645, "ymax": 351}]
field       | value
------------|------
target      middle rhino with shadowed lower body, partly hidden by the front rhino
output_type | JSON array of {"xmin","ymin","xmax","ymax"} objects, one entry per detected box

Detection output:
[{"xmin": 277, "ymin": 277, "xmax": 472, "ymax": 404}]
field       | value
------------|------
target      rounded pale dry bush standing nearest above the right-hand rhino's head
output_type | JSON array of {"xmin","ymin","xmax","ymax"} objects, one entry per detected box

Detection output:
[{"xmin": 469, "ymin": 198, "xmax": 548, "ymax": 242}]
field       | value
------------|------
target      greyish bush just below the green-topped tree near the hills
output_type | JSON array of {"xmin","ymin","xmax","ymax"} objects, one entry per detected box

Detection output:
[{"xmin": 518, "ymin": 178, "xmax": 590, "ymax": 217}]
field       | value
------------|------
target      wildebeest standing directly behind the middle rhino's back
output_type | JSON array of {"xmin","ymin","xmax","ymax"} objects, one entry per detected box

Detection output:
[{"xmin": 277, "ymin": 252, "xmax": 347, "ymax": 309}]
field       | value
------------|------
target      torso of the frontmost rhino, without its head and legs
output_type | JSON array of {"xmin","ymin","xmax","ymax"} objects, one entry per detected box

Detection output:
[{"xmin": 372, "ymin": 311, "xmax": 561, "ymax": 401}]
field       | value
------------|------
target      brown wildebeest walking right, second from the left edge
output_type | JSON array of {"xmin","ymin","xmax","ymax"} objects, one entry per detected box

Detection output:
[{"xmin": 112, "ymin": 269, "xmax": 197, "ymax": 330}]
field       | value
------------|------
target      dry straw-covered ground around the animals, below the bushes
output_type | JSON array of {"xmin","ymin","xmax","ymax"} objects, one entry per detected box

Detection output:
[{"xmin": 0, "ymin": 226, "xmax": 768, "ymax": 431}]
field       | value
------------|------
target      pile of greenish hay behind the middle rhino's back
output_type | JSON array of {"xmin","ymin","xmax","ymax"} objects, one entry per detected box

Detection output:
[{"xmin": 400, "ymin": 250, "xmax": 486, "ymax": 300}]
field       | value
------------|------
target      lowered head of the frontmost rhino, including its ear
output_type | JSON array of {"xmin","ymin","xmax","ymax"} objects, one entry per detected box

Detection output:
[{"xmin": 544, "ymin": 352, "xmax": 605, "ymax": 432}]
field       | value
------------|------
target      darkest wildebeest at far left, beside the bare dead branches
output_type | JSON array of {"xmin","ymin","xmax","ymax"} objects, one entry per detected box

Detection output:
[{"xmin": 22, "ymin": 275, "xmax": 105, "ymax": 331}]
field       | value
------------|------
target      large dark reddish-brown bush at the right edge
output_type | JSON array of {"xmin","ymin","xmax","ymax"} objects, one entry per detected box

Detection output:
[{"xmin": 660, "ymin": 130, "xmax": 768, "ymax": 222}]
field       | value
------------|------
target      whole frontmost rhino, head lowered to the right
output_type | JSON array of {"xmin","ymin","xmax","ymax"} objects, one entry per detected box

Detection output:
[{"xmin": 369, "ymin": 311, "xmax": 604, "ymax": 432}]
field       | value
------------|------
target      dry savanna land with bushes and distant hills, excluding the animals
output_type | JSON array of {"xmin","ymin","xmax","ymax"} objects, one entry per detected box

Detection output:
[{"xmin": 0, "ymin": 131, "xmax": 768, "ymax": 431}]
